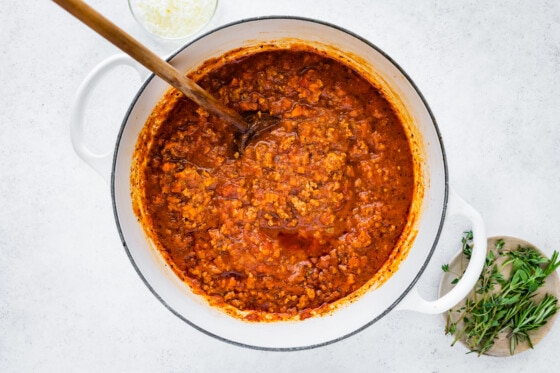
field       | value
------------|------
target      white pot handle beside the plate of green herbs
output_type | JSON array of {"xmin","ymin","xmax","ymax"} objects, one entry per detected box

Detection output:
[{"xmin": 396, "ymin": 188, "xmax": 487, "ymax": 314}]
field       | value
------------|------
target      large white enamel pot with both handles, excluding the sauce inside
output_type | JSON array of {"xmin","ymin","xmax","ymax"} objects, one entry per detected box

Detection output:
[{"xmin": 71, "ymin": 17, "xmax": 486, "ymax": 350}]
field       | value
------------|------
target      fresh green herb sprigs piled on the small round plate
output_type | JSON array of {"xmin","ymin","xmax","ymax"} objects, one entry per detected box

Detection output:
[{"xmin": 442, "ymin": 232, "xmax": 560, "ymax": 355}]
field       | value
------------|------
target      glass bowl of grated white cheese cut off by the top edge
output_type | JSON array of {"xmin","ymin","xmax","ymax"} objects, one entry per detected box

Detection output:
[{"xmin": 129, "ymin": 0, "xmax": 218, "ymax": 39}]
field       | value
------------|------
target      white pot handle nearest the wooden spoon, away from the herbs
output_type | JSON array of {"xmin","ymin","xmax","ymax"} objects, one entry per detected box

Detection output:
[{"xmin": 70, "ymin": 54, "xmax": 148, "ymax": 181}]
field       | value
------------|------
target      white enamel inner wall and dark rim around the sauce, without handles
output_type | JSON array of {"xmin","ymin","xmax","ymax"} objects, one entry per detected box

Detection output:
[{"xmin": 111, "ymin": 17, "xmax": 448, "ymax": 349}]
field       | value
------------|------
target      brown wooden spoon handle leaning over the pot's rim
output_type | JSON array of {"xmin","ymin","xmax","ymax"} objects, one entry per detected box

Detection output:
[{"xmin": 53, "ymin": 0, "xmax": 249, "ymax": 133}]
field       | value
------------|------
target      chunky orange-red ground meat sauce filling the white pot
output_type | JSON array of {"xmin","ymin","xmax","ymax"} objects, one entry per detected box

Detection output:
[{"xmin": 135, "ymin": 49, "xmax": 414, "ymax": 320}]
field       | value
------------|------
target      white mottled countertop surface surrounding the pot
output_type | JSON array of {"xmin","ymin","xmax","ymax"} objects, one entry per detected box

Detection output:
[{"xmin": 0, "ymin": 0, "xmax": 560, "ymax": 372}]
